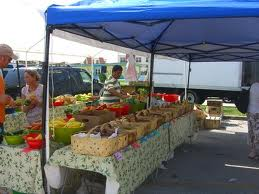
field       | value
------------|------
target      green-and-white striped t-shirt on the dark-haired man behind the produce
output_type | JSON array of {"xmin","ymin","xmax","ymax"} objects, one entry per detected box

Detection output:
[{"xmin": 100, "ymin": 76, "xmax": 121, "ymax": 103}]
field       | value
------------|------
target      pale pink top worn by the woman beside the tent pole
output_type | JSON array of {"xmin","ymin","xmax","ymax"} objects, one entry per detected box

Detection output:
[{"xmin": 22, "ymin": 84, "xmax": 43, "ymax": 124}]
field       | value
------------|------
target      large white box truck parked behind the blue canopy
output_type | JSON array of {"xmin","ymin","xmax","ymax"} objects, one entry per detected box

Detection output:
[{"xmin": 153, "ymin": 57, "xmax": 259, "ymax": 107}]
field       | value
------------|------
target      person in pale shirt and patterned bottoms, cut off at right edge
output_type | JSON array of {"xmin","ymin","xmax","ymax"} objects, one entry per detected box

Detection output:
[{"xmin": 247, "ymin": 82, "xmax": 259, "ymax": 159}]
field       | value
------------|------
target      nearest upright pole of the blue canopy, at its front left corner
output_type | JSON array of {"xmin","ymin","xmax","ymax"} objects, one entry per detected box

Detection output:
[{"xmin": 41, "ymin": 26, "xmax": 52, "ymax": 194}]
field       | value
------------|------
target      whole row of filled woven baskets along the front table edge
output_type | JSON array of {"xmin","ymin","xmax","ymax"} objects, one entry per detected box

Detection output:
[{"xmin": 71, "ymin": 102, "xmax": 193, "ymax": 156}]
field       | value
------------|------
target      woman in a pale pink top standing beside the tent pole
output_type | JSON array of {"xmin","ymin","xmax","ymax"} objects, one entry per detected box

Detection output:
[{"xmin": 22, "ymin": 70, "xmax": 43, "ymax": 124}]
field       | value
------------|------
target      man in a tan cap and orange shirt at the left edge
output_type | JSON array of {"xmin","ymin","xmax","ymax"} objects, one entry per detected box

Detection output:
[{"xmin": 0, "ymin": 44, "xmax": 18, "ymax": 143}]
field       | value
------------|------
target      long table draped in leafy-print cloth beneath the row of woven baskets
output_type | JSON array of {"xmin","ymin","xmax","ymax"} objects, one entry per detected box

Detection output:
[{"xmin": 49, "ymin": 113, "xmax": 195, "ymax": 194}]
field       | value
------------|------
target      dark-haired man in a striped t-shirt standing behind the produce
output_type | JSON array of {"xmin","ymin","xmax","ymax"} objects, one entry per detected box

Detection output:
[{"xmin": 100, "ymin": 65, "xmax": 128, "ymax": 104}]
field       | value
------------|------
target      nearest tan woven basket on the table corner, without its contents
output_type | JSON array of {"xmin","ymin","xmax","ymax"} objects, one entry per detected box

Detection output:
[{"xmin": 71, "ymin": 129, "xmax": 122, "ymax": 157}]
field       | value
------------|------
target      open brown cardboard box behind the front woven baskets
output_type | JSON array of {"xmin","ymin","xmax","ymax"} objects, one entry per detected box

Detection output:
[{"xmin": 74, "ymin": 110, "xmax": 115, "ymax": 129}]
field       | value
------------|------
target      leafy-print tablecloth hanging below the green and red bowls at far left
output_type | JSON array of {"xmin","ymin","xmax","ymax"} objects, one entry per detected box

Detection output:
[{"xmin": 0, "ymin": 145, "xmax": 44, "ymax": 194}]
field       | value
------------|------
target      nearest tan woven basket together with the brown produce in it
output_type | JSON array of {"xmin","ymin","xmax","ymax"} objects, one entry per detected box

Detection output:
[{"xmin": 71, "ymin": 124, "xmax": 128, "ymax": 157}]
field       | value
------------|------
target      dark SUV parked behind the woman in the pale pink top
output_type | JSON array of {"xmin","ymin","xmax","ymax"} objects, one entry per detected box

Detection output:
[{"xmin": 3, "ymin": 67, "xmax": 103, "ymax": 98}]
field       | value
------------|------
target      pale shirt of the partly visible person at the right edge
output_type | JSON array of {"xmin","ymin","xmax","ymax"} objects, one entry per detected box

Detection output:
[{"xmin": 248, "ymin": 82, "xmax": 259, "ymax": 113}]
